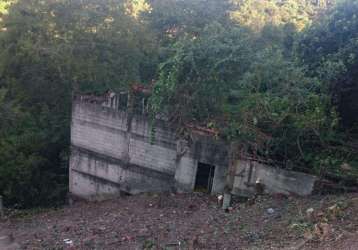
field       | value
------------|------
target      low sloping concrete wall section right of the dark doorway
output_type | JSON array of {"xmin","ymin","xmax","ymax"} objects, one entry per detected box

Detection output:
[{"xmin": 234, "ymin": 160, "xmax": 316, "ymax": 196}]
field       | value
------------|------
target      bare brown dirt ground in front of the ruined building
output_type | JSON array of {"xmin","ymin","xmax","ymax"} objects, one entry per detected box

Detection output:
[{"xmin": 0, "ymin": 194, "xmax": 358, "ymax": 250}]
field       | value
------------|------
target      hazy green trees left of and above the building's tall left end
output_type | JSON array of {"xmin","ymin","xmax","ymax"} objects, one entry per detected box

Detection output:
[{"xmin": 0, "ymin": 0, "xmax": 156, "ymax": 207}]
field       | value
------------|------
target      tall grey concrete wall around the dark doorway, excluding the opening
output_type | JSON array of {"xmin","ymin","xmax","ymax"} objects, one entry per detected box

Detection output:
[{"xmin": 70, "ymin": 98, "xmax": 227, "ymax": 199}]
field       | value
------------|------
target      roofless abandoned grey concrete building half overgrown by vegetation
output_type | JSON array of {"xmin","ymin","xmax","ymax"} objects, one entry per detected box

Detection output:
[{"xmin": 69, "ymin": 91, "xmax": 315, "ymax": 200}]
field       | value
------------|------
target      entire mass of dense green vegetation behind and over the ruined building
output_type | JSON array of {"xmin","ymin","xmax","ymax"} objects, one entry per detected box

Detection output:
[{"xmin": 0, "ymin": 0, "xmax": 358, "ymax": 207}]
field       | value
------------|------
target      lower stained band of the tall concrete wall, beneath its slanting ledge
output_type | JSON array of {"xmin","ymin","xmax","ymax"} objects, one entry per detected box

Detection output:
[{"xmin": 70, "ymin": 147, "xmax": 173, "ymax": 200}]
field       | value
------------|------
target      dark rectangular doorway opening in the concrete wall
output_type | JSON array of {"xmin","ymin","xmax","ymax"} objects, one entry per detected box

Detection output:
[{"xmin": 194, "ymin": 162, "xmax": 215, "ymax": 193}]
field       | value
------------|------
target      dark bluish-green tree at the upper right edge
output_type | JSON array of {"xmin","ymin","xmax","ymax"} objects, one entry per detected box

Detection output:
[{"xmin": 298, "ymin": 0, "xmax": 358, "ymax": 129}]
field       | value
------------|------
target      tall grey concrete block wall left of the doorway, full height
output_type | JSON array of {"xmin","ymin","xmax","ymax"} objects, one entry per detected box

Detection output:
[{"xmin": 70, "ymin": 100, "xmax": 176, "ymax": 199}]
